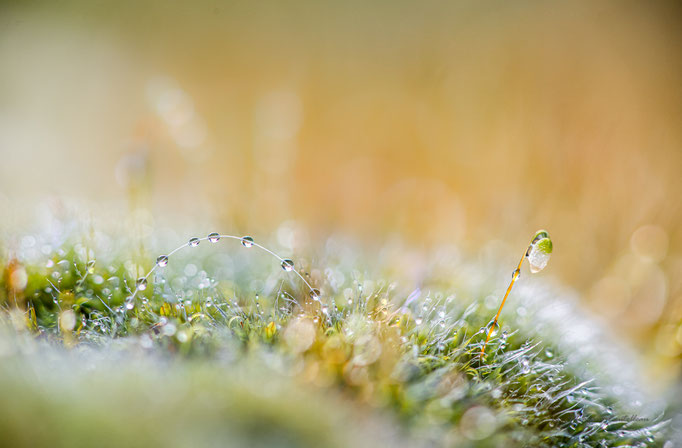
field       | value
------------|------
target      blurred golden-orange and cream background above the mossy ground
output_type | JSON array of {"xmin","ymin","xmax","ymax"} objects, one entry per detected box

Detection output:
[{"xmin": 0, "ymin": 0, "xmax": 682, "ymax": 380}]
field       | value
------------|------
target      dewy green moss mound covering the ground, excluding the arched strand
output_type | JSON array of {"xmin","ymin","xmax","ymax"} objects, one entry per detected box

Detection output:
[{"xmin": 0, "ymin": 233, "xmax": 666, "ymax": 447}]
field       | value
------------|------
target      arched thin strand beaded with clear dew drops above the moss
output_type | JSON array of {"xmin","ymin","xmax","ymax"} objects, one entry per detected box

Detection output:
[{"xmin": 126, "ymin": 232, "xmax": 321, "ymax": 310}]
